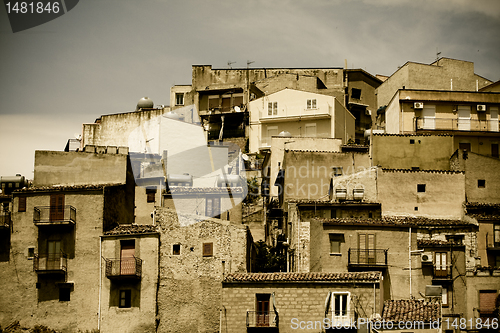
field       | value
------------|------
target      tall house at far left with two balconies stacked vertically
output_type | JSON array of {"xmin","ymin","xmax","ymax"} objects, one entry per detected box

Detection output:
[{"xmin": 0, "ymin": 184, "xmax": 133, "ymax": 332}]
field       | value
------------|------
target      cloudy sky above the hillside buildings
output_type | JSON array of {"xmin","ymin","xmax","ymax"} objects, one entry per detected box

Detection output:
[{"xmin": 0, "ymin": 0, "xmax": 500, "ymax": 178}]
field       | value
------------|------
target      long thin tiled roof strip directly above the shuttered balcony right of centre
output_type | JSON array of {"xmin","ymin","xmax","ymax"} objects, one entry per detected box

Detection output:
[{"xmin": 316, "ymin": 217, "xmax": 476, "ymax": 227}]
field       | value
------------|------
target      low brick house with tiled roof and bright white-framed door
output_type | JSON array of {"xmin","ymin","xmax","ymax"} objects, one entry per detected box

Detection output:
[{"xmin": 220, "ymin": 272, "xmax": 383, "ymax": 333}]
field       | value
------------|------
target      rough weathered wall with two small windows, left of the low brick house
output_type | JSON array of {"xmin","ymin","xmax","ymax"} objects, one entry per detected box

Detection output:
[{"xmin": 156, "ymin": 209, "xmax": 247, "ymax": 332}]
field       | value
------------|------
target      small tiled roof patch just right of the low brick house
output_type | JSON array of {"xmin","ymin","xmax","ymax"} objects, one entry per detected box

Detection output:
[{"xmin": 382, "ymin": 299, "xmax": 441, "ymax": 323}]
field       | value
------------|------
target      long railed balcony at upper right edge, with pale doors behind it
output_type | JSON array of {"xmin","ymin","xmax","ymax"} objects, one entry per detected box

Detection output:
[{"xmin": 415, "ymin": 118, "xmax": 499, "ymax": 132}]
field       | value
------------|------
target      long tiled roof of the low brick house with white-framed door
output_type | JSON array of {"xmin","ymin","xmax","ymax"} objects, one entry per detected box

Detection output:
[{"xmin": 224, "ymin": 272, "xmax": 382, "ymax": 283}]
